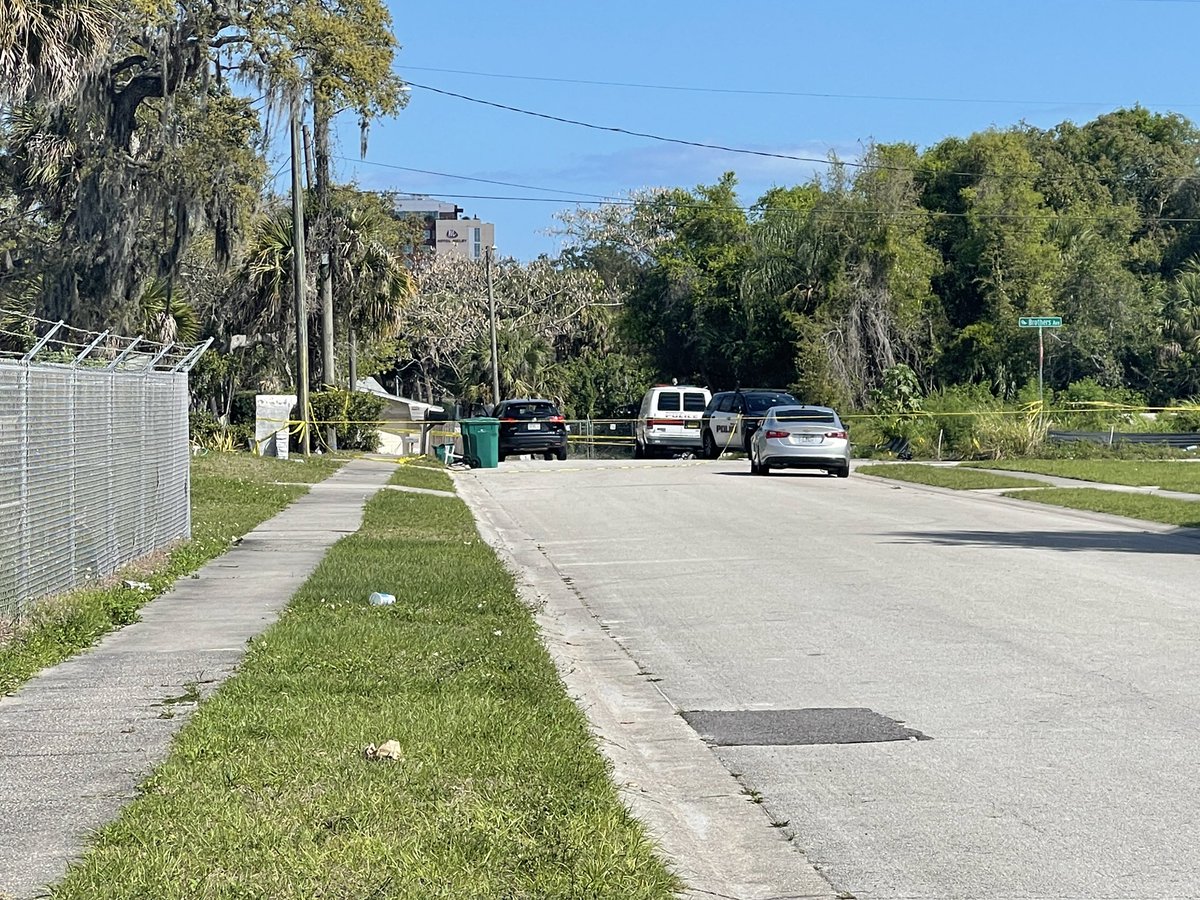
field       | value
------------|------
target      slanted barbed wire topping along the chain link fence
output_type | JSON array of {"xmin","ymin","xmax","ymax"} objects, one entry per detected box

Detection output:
[{"xmin": 0, "ymin": 307, "xmax": 212, "ymax": 374}]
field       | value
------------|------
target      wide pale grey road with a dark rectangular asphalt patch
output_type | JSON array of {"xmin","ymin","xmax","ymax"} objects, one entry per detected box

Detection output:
[{"xmin": 465, "ymin": 461, "xmax": 1200, "ymax": 900}]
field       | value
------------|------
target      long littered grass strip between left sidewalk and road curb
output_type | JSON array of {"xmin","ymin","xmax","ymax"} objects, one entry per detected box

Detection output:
[{"xmin": 52, "ymin": 491, "xmax": 678, "ymax": 900}]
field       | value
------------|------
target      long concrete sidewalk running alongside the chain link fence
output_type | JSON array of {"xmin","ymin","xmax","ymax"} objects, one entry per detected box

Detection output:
[{"xmin": 0, "ymin": 460, "xmax": 395, "ymax": 900}]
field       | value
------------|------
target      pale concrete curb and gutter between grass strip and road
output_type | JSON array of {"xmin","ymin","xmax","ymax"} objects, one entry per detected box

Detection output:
[{"xmin": 455, "ymin": 473, "xmax": 838, "ymax": 900}]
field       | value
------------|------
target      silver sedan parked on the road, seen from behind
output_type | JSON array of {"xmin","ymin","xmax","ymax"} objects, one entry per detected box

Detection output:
[{"xmin": 750, "ymin": 407, "xmax": 850, "ymax": 478}]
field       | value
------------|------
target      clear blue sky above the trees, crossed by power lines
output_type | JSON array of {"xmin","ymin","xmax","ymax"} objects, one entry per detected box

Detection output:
[{"xmin": 319, "ymin": 0, "xmax": 1200, "ymax": 259}]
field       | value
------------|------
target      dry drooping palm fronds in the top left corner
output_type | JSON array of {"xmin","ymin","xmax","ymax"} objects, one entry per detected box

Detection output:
[{"xmin": 0, "ymin": 0, "xmax": 118, "ymax": 106}]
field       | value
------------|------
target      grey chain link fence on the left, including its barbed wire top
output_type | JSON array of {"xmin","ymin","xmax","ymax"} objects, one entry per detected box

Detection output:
[{"xmin": 0, "ymin": 311, "xmax": 208, "ymax": 620}]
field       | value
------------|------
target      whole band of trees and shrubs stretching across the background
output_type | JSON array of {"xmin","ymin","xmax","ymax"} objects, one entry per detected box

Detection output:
[{"xmin": 7, "ymin": 0, "xmax": 1200, "ymax": 436}]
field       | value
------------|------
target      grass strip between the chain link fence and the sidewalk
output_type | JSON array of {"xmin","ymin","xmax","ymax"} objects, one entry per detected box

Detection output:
[{"xmin": 0, "ymin": 454, "xmax": 344, "ymax": 694}]
